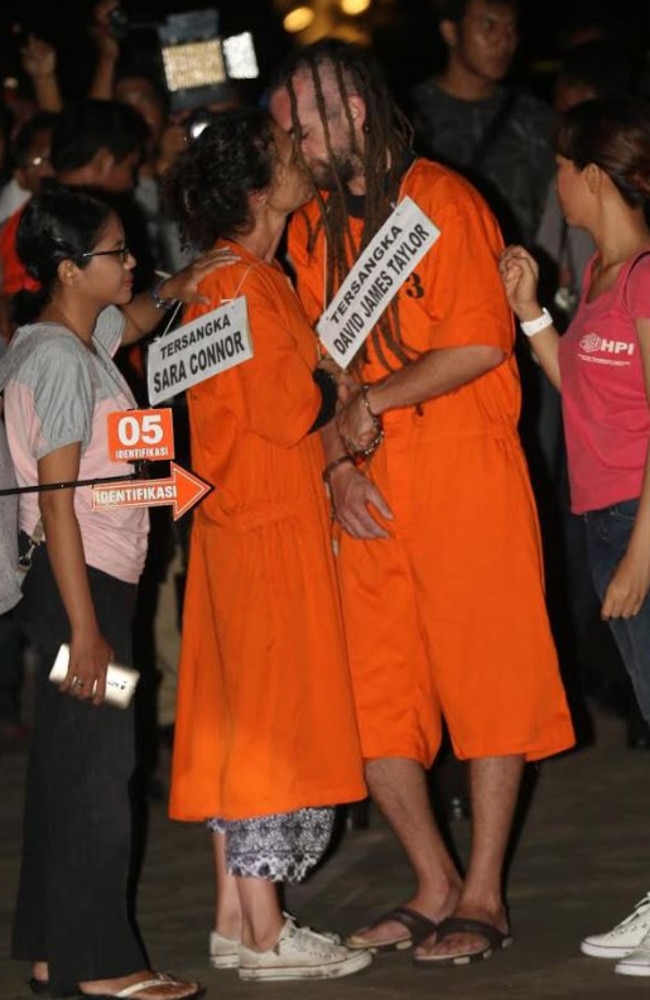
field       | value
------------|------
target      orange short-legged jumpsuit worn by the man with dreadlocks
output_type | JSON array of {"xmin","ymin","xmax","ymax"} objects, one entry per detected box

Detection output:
[{"xmin": 289, "ymin": 159, "xmax": 574, "ymax": 766}]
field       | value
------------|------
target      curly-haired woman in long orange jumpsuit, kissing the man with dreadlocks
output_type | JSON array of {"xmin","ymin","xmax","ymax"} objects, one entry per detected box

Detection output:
[{"xmin": 162, "ymin": 110, "xmax": 368, "ymax": 980}]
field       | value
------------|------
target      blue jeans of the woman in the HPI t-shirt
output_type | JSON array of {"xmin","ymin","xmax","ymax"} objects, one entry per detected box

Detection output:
[{"xmin": 583, "ymin": 500, "xmax": 650, "ymax": 724}]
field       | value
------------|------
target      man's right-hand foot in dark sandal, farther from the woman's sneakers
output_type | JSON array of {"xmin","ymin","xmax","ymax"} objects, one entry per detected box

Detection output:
[{"xmin": 413, "ymin": 909, "xmax": 513, "ymax": 966}]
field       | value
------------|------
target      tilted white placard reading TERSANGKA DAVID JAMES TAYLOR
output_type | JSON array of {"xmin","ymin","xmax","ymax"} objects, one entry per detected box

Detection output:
[{"xmin": 316, "ymin": 197, "xmax": 440, "ymax": 368}]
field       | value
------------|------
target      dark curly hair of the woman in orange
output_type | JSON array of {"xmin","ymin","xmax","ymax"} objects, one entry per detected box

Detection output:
[{"xmin": 163, "ymin": 108, "xmax": 275, "ymax": 250}]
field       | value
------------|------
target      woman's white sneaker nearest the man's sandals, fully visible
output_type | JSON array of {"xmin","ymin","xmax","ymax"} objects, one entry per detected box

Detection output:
[{"xmin": 239, "ymin": 917, "xmax": 372, "ymax": 981}]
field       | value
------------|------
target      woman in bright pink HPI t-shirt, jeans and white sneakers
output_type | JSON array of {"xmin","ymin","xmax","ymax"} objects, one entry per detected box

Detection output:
[{"xmin": 501, "ymin": 97, "xmax": 650, "ymax": 976}]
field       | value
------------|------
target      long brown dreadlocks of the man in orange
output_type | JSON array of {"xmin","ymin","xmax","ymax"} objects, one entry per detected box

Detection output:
[{"xmin": 271, "ymin": 38, "xmax": 417, "ymax": 371}]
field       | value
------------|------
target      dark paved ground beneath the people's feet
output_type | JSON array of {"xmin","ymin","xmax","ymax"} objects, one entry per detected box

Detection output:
[{"xmin": 0, "ymin": 704, "xmax": 650, "ymax": 1000}]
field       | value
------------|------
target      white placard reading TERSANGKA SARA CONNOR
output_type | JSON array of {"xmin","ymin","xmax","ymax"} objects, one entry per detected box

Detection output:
[{"xmin": 147, "ymin": 295, "xmax": 253, "ymax": 406}]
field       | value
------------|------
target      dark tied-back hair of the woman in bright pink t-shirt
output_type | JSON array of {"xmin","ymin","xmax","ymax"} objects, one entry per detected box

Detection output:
[{"xmin": 555, "ymin": 96, "xmax": 650, "ymax": 208}]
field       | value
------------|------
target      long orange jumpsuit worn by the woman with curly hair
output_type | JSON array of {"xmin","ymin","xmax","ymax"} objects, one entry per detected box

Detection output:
[{"xmin": 170, "ymin": 246, "xmax": 366, "ymax": 820}]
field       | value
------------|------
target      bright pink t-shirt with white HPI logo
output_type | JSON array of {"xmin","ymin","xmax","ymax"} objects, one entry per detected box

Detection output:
[{"xmin": 559, "ymin": 254, "xmax": 650, "ymax": 514}]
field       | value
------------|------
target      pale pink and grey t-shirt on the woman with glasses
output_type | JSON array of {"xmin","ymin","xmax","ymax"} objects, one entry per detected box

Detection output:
[{"xmin": 5, "ymin": 306, "xmax": 149, "ymax": 583}]
